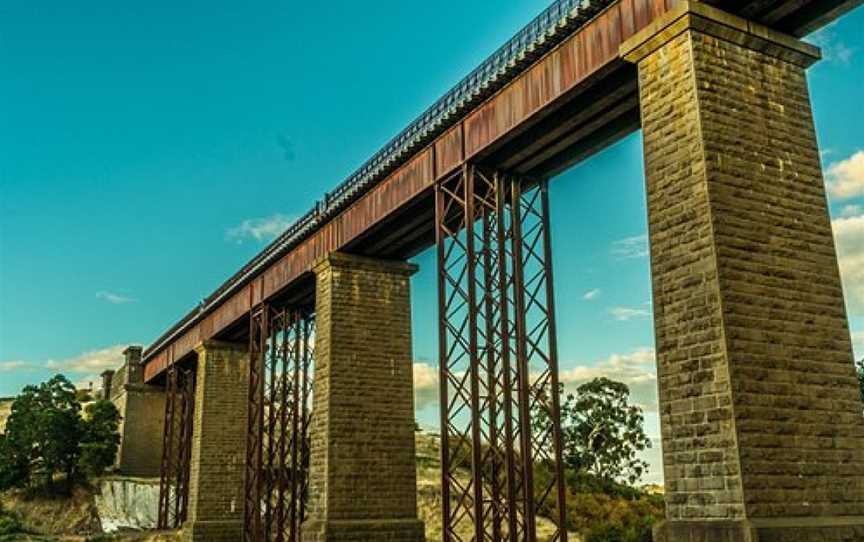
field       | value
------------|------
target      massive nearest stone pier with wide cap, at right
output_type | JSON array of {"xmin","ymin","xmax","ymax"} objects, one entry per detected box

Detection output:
[{"xmin": 621, "ymin": 2, "xmax": 864, "ymax": 542}]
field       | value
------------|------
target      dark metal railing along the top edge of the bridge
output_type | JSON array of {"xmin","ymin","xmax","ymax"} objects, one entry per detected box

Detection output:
[{"xmin": 144, "ymin": 0, "xmax": 615, "ymax": 366}]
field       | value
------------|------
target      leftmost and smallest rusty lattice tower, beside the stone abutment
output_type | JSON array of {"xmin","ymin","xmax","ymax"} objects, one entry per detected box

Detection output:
[{"xmin": 158, "ymin": 365, "xmax": 195, "ymax": 529}]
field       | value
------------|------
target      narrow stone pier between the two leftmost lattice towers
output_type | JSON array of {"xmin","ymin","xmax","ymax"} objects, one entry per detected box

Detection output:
[{"xmin": 183, "ymin": 340, "xmax": 249, "ymax": 542}]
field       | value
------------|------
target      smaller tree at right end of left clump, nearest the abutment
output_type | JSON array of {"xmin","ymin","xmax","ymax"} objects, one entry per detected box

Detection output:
[{"xmin": 79, "ymin": 400, "xmax": 120, "ymax": 476}]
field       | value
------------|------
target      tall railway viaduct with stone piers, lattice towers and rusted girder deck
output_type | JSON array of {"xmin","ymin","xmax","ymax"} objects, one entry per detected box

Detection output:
[{"xmin": 109, "ymin": 0, "xmax": 864, "ymax": 542}]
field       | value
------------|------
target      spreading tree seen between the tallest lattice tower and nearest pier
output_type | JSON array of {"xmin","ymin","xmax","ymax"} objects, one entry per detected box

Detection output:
[{"xmin": 561, "ymin": 378, "xmax": 651, "ymax": 485}]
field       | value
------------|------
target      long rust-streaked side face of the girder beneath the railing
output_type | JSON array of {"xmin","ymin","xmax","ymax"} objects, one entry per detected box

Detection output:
[{"xmin": 144, "ymin": 0, "xmax": 668, "ymax": 380}]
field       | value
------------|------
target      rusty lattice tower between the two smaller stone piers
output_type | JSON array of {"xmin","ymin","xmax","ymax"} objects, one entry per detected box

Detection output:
[{"xmin": 243, "ymin": 305, "xmax": 315, "ymax": 542}]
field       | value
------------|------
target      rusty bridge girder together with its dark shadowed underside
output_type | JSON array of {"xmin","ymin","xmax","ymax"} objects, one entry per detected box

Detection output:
[{"xmin": 145, "ymin": 0, "xmax": 861, "ymax": 381}]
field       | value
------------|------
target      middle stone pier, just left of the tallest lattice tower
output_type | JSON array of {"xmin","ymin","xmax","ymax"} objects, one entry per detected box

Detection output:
[{"xmin": 302, "ymin": 253, "xmax": 424, "ymax": 542}]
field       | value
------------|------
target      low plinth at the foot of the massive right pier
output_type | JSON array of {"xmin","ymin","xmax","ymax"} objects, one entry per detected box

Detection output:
[{"xmin": 654, "ymin": 516, "xmax": 864, "ymax": 542}]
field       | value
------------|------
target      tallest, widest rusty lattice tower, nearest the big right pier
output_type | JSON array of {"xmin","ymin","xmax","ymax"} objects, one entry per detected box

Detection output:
[{"xmin": 436, "ymin": 165, "xmax": 567, "ymax": 542}]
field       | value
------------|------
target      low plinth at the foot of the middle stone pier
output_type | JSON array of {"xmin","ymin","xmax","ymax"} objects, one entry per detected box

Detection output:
[{"xmin": 301, "ymin": 519, "xmax": 426, "ymax": 542}]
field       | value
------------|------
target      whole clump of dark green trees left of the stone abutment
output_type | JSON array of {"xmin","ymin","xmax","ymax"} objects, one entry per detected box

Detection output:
[{"xmin": 0, "ymin": 375, "xmax": 120, "ymax": 494}]
